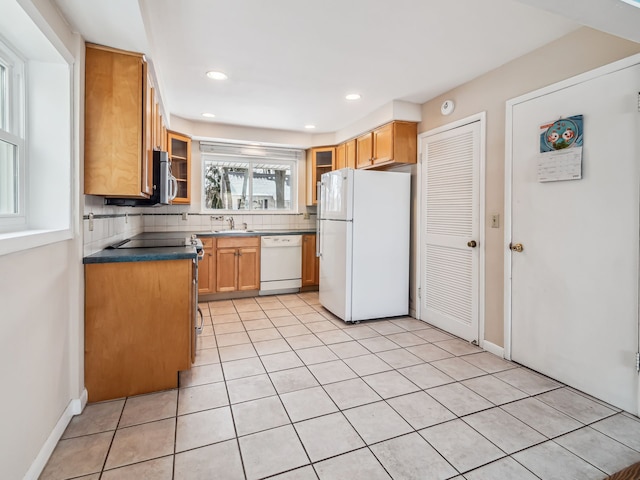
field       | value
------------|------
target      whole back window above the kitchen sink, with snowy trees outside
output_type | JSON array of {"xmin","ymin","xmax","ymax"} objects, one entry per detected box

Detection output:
[{"xmin": 201, "ymin": 144, "xmax": 302, "ymax": 212}]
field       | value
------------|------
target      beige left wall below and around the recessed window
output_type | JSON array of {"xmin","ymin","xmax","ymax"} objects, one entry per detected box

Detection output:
[{"xmin": 0, "ymin": 0, "xmax": 84, "ymax": 479}]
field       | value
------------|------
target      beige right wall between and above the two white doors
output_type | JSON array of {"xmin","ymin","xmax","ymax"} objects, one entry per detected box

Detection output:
[{"xmin": 418, "ymin": 27, "xmax": 640, "ymax": 346}]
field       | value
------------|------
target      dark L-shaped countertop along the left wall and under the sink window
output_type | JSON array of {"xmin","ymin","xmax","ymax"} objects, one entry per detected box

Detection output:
[{"xmin": 82, "ymin": 229, "xmax": 316, "ymax": 265}]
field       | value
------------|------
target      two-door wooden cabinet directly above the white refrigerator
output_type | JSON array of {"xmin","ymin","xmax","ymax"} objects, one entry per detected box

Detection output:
[{"xmin": 356, "ymin": 122, "xmax": 418, "ymax": 168}]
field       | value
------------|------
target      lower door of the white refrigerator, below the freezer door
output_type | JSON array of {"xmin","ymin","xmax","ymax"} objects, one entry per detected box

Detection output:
[{"xmin": 319, "ymin": 220, "xmax": 353, "ymax": 322}]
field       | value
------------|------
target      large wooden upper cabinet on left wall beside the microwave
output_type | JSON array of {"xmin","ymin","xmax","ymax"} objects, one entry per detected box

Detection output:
[{"xmin": 84, "ymin": 44, "xmax": 153, "ymax": 198}]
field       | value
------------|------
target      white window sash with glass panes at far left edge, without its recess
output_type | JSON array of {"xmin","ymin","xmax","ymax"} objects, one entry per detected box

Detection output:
[{"xmin": 0, "ymin": 42, "xmax": 24, "ymax": 222}]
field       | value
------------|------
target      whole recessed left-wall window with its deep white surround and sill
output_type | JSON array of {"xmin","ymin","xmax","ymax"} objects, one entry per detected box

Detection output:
[{"xmin": 0, "ymin": 0, "xmax": 73, "ymax": 255}]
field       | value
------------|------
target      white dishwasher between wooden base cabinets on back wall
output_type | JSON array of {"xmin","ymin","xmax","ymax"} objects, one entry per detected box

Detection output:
[{"xmin": 260, "ymin": 235, "xmax": 302, "ymax": 295}]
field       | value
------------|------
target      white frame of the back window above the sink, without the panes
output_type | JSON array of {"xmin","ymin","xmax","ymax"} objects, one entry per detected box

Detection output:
[{"xmin": 200, "ymin": 152, "xmax": 298, "ymax": 215}]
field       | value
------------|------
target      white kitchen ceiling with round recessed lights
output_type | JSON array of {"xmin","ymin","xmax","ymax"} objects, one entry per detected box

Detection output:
[{"xmin": 53, "ymin": 0, "xmax": 640, "ymax": 133}]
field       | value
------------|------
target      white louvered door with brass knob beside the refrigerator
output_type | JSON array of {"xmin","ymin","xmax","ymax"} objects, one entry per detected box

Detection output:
[{"xmin": 420, "ymin": 121, "xmax": 482, "ymax": 341}]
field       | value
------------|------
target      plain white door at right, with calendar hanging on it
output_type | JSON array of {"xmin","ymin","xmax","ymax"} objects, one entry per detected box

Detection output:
[{"xmin": 506, "ymin": 60, "xmax": 640, "ymax": 412}]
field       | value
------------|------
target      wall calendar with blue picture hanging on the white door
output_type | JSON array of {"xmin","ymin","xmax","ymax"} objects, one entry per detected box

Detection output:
[{"xmin": 538, "ymin": 115, "xmax": 584, "ymax": 182}]
